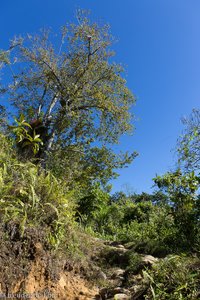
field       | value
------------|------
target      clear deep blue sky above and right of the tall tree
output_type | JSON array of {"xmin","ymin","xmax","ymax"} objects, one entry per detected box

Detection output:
[{"xmin": 0, "ymin": 0, "xmax": 200, "ymax": 192}]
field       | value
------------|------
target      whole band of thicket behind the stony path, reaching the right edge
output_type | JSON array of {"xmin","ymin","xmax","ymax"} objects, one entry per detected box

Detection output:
[{"xmin": 77, "ymin": 172, "xmax": 200, "ymax": 256}]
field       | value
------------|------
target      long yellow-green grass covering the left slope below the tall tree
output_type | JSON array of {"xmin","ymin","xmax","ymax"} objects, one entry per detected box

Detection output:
[{"xmin": 0, "ymin": 136, "xmax": 74, "ymax": 247}]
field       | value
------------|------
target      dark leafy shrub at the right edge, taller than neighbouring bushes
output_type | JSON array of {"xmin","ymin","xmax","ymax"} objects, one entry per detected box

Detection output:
[{"xmin": 154, "ymin": 170, "xmax": 200, "ymax": 247}]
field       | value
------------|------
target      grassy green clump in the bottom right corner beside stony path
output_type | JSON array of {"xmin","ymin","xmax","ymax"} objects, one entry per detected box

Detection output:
[{"xmin": 145, "ymin": 255, "xmax": 200, "ymax": 300}]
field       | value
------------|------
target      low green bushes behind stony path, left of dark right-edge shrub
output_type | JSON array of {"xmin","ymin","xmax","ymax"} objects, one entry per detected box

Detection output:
[{"xmin": 79, "ymin": 186, "xmax": 181, "ymax": 256}]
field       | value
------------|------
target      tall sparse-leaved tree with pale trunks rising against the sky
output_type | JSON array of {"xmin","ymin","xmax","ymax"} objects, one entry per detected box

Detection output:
[{"xmin": 0, "ymin": 12, "xmax": 135, "ymax": 183}]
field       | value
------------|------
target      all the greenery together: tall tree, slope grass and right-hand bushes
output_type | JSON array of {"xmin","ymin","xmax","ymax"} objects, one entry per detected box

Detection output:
[{"xmin": 0, "ymin": 10, "xmax": 200, "ymax": 299}]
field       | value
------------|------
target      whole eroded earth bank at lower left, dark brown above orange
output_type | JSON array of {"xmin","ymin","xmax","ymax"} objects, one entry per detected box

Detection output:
[{"xmin": 0, "ymin": 225, "xmax": 98, "ymax": 300}]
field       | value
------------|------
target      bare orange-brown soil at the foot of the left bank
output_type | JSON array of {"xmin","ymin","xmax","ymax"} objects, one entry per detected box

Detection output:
[{"xmin": 0, "ymin": 245, "xmax": 98, "ymax": 300}]
